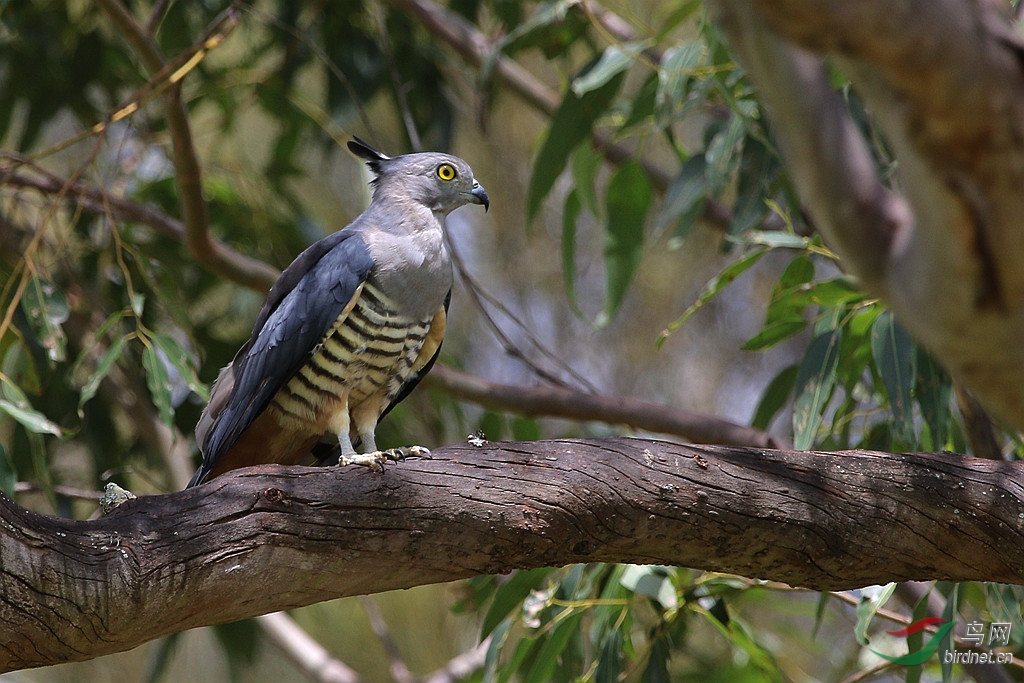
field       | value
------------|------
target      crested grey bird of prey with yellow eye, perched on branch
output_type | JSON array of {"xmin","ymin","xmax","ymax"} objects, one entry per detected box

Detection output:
[{"xmin": 188, "ymin": 136, "xmax": 490, "ymax": 487}]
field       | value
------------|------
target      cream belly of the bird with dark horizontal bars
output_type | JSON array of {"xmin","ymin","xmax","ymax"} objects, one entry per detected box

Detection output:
[{"xmin": 271, "ymin": 283, "xmax": 430, "ymax": 429}]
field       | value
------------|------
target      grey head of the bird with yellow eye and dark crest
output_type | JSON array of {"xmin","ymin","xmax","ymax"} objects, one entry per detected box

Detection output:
[{"xmin": 348, "ymin": 138, "xmax": 490, "ymax": 214}]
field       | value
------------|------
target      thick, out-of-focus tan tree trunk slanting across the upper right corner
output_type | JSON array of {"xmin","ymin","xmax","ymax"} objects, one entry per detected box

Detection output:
[{"xmin": 714, "ymin": 0, "xmax": 1024, "ymax": 428}]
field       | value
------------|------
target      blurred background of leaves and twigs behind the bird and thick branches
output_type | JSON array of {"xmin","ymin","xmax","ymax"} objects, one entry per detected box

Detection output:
[{"xmin": 0, "ymin": 0, "xmax": 1024, "ymax": 683}]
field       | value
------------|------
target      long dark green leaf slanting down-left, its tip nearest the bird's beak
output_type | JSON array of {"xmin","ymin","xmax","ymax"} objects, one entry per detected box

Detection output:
[{"xmin": 526, "ymin": 63, "xmax": 625, "ymax": 220}]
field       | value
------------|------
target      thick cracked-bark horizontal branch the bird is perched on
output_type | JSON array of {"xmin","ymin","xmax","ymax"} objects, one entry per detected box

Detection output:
[{"xmin": 0, "ymin": 438, "xmax": 1024, "ymax": 671}]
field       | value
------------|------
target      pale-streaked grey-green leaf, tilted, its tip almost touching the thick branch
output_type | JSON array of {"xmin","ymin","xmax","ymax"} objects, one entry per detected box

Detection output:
[{"xmin": 793, "ymin": 329, "xmax": 841, "ymax": 451}]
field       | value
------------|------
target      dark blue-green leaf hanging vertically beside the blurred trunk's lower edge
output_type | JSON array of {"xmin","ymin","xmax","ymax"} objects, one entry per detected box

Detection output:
[{"xmin": 871, "ymin": 310, "xmax": 914, "ymax": 445}]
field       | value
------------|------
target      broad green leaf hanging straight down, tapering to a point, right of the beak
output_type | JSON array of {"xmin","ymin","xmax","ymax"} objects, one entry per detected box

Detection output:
[{"xmin": 599, "ymin": 162, "xmax": 651, "ymax": 324}]
